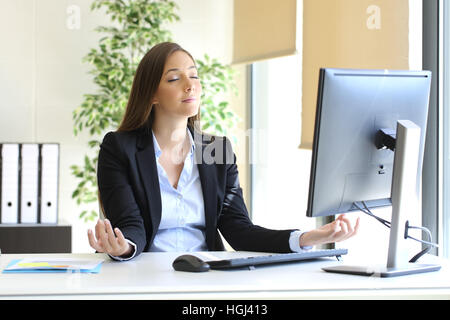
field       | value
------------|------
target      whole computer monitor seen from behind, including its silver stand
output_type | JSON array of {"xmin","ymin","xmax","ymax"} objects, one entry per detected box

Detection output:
[{"xmin": 307, "ymin": 69, "xmax": 440, "ymax": 276}]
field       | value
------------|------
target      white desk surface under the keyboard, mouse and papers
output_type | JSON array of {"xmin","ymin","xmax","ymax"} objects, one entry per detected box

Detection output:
[{"xmin": 0, "ymin": 252, "xmax": 450, "ymax": 299}]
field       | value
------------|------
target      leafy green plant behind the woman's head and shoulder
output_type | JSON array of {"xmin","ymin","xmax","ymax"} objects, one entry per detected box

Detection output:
[{"xmin": 71, "ymin": 0, "xmax": 238, "ymax": 221}]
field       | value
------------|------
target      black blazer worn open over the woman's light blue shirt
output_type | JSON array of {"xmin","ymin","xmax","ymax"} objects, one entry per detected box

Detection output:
[{"xmin": 97, "ymin": 127, "xmax": 293, "ymax": 256}]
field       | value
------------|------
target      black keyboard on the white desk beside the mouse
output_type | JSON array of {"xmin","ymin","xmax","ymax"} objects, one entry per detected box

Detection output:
[{"xmin": 205, "ymin": 249, "xmax": 348, "ymax": 269}]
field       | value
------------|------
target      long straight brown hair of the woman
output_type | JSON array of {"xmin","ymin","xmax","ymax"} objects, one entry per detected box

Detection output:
[{"xmin": 117, "ymin": 42, "xmax": 200, "ymax": 131}]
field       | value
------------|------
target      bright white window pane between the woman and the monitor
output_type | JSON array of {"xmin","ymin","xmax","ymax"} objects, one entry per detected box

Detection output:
[{"xmin": 250, "ymin": 55, "xmax": 315, "ymax": 235}]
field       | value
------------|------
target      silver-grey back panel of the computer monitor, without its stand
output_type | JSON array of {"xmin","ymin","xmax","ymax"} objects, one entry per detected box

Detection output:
[{"xmin": 307, "ymin": 69, "xmax": 431, "ymax": 217}]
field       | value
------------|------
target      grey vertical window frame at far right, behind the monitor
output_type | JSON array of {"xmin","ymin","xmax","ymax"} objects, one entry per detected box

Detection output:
[{"xmin": 422, "ymin": 0, "xmax": 450, "ymax": 257}]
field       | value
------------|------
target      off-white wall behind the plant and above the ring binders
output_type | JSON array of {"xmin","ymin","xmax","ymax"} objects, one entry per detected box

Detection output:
[{"xmin": 0, "ymin": 0, "xmax": 233, "ymax": 252}]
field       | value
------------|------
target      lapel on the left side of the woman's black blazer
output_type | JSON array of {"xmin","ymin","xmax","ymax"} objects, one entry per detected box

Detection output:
[{"xmin": 136, "ymin": 131, "xmax": 162, "ymax": 242}]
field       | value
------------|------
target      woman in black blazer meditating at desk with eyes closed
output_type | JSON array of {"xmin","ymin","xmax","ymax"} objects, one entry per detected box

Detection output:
[{"xmin": 88, "ymin": 42, "xmax": 359, "ymax": 260}]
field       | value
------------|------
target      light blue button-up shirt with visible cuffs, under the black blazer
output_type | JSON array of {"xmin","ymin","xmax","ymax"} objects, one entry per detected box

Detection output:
[{"xmin": 113, "ymin": 129, "xmax": 311, "ymax": 260}]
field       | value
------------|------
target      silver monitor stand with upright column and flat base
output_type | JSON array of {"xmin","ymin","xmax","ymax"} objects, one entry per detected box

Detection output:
[{"xmin": 322, "ymin": 120, "xmax": 441, "ymax": 277}]
